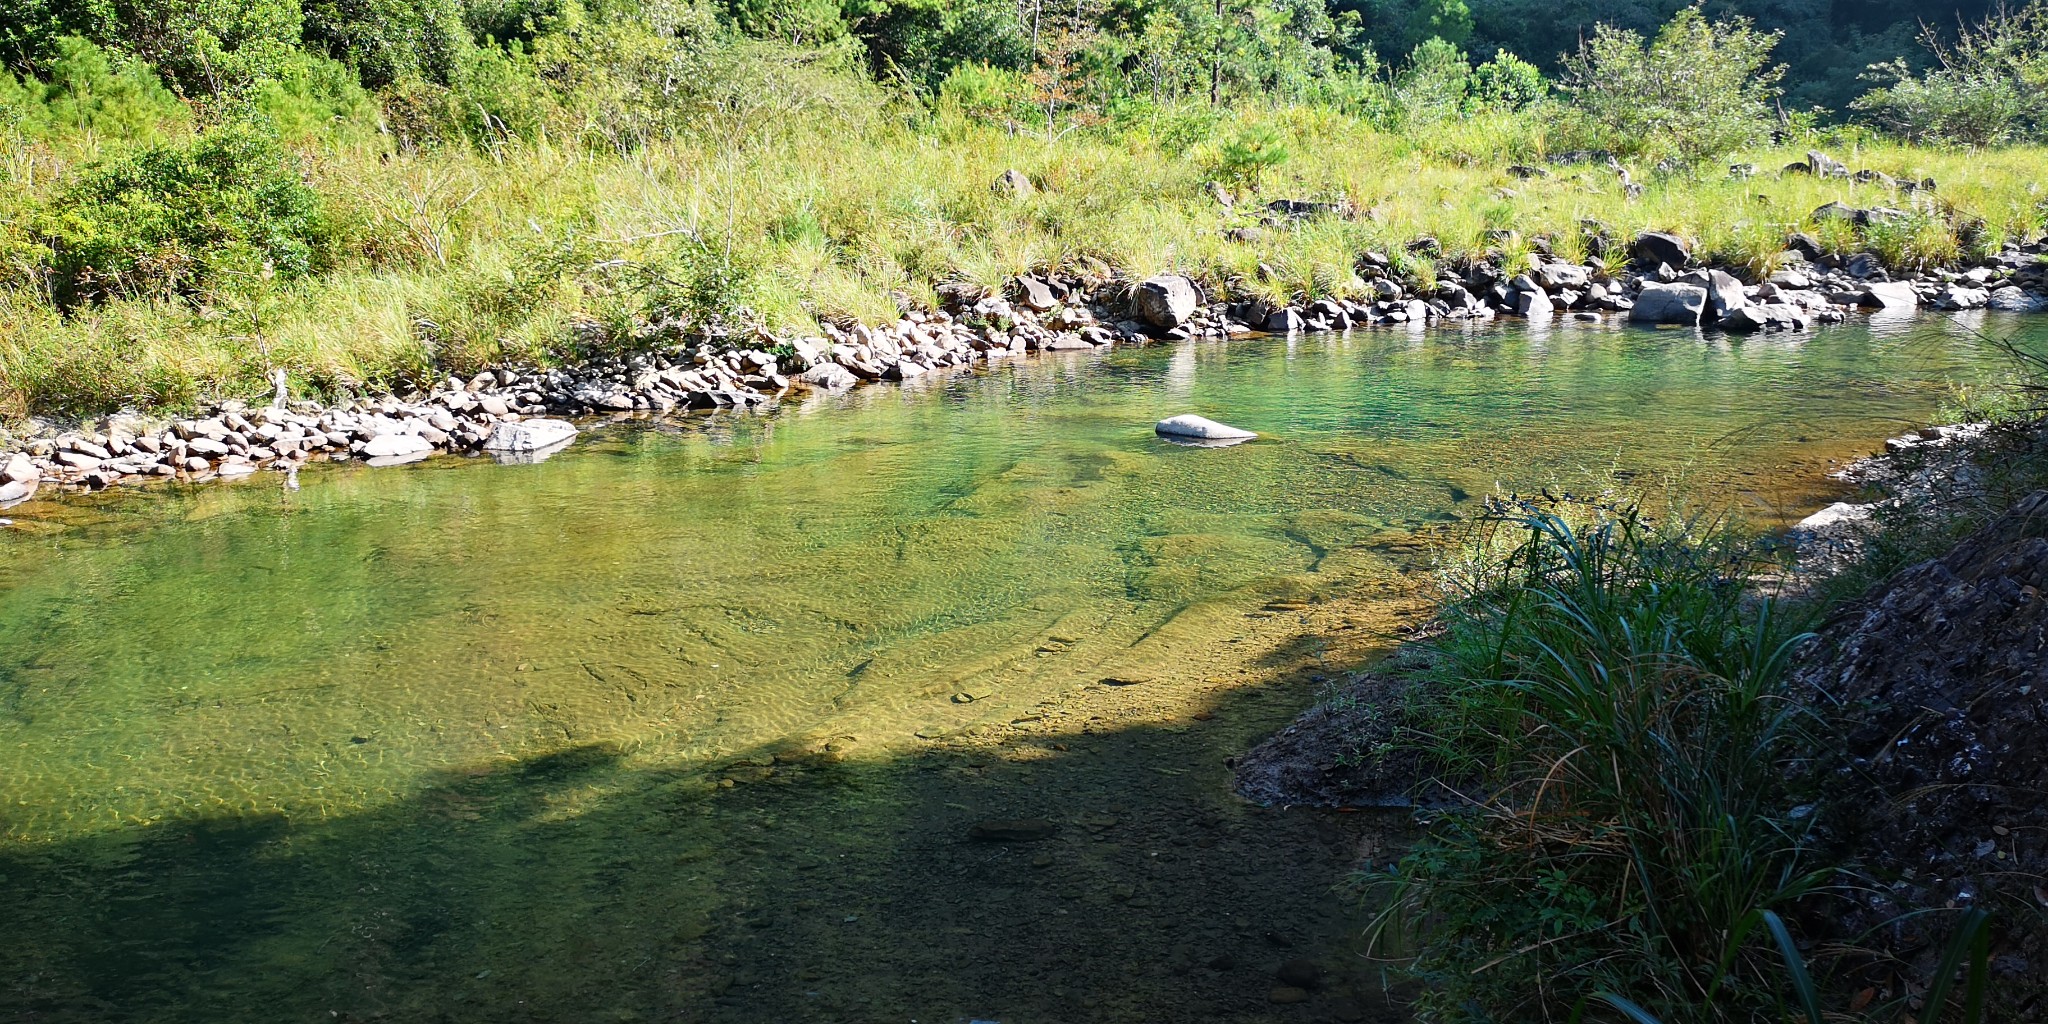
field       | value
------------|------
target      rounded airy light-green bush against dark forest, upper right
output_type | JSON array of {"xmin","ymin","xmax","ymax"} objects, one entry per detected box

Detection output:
[{"xmin": 1565, "ymin": 6, "xmax": 1784, "ymax": 162}]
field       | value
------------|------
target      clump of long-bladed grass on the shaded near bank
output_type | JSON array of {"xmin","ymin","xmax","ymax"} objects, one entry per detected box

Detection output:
[{"xmin": 1376, "ymin": 493, "xmax": 1831, "ymax": 1024}]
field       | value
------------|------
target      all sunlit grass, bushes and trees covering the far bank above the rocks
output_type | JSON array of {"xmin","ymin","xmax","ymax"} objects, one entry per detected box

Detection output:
[{"xmin": 0, "ymin": 0, "xmax": 2048, "ymax": 416}]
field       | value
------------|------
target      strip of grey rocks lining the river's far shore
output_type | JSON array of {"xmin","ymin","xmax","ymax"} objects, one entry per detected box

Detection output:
[{"xmin": 0, "ymin": 175, "xmax": 2048, "ymax": 508}]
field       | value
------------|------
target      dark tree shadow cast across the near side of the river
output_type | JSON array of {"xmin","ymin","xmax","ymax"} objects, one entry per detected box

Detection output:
[{"xmin": 0, "ymin": 639, "xmax": 1403, "ymax": 1022}]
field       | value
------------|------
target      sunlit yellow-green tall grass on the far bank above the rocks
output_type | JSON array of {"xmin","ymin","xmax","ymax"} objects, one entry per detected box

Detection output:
[{"xmin": 0, "ymin": 84, "xmax": 2044, "ymax": 414}]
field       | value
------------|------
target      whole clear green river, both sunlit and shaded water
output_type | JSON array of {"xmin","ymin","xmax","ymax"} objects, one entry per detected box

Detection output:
[{"xmin": 0, "ymin": 317, "xmax": 2044, "ymax": 1024}]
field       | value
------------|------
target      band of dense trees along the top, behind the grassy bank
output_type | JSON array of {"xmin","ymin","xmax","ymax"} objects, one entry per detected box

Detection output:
[{"xmin": 0, "ymin": 0, "xmax": 2015, "ymax": 117}]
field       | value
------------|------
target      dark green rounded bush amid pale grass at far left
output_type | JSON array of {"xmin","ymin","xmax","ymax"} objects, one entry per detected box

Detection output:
[{"xmin": 37, "ymin": 125, "xmax": 330, "ymax": 305}]
